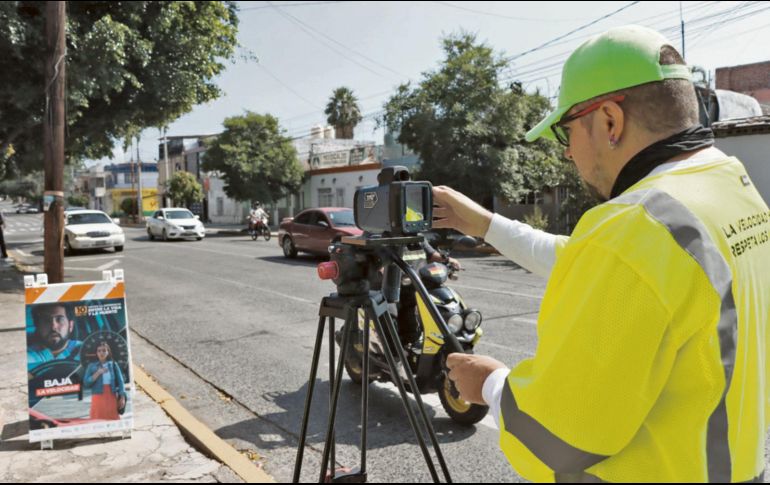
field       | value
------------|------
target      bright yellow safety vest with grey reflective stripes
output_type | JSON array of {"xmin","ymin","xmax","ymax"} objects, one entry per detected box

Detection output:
[{"xmin": 500, "ymin": 158, "xmax": 770, "ymax": 482}]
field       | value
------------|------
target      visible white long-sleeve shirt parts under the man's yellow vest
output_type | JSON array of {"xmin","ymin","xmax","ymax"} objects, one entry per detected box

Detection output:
[{"xmin": 481, "ymin": 147, "xmax": 727, "ymax": 428}]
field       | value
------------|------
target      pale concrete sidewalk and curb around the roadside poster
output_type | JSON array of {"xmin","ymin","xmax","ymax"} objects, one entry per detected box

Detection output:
[{"xmin": 0, "ymin": 260, "xmax": 271, "ymax": 483}]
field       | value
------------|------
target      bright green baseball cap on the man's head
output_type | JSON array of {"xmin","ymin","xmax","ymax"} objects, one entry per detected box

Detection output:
[{"xmin": 526, "ymin": 25, "xmax": 692, "ymax": 141}]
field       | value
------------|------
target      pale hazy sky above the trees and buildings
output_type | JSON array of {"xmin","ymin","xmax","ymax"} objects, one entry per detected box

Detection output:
[{"xmin": 89, "ymin": 0, "xmax": 770, "ymax": 165}]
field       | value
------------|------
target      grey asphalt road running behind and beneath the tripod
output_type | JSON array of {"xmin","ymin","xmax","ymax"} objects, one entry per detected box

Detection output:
[{"xmin": 3, "ymin": 206, "xmax": 544, "ymax": 482}]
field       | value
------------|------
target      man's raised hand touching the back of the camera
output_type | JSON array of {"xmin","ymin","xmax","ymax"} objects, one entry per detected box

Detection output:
[{"xmin": 433, "ymin": 185, "xmax": 492, "ymax": 237}]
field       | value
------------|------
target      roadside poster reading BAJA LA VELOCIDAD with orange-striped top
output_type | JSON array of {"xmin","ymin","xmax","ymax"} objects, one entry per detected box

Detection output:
[{"xmin": 25, "ymin": 270, "xmax": 134, "ymax": 442}]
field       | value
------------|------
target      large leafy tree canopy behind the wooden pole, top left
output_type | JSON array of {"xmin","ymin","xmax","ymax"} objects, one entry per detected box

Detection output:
[{"xmin": 0, "ymin": 1, "xmax": 238, "ymax": 178}]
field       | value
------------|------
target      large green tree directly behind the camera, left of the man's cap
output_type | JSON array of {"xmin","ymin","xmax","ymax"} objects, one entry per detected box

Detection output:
[{"xmin": 383, "ymin": 33, "xmax": 561, "ymax": 207}]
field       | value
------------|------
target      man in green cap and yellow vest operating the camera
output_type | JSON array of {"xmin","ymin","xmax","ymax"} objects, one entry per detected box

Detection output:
[{"xmin": 434, "ymin": 26, "xmax": 770, "ymax": 482}]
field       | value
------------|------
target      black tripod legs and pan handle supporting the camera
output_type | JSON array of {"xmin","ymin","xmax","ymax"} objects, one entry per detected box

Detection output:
[{"xmin": 293, "ymin": 240, "xmax": 462, "ymax": 483}]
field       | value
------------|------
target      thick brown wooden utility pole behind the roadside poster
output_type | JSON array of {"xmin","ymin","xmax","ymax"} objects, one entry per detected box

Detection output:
[{"xmin": 43, "ymin": 2, "xmax": 66, "ymax": 283}]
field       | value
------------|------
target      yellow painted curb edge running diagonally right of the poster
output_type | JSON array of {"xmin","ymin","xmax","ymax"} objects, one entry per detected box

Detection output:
[{"xmin": 133, "ymin": 366, "xmax": 275, "ymax": 483}]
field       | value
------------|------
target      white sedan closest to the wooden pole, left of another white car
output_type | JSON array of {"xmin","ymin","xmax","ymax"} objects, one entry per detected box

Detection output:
[{"xmin": 64, "ymin": 210, "xmax": 126, "ymax": 254}]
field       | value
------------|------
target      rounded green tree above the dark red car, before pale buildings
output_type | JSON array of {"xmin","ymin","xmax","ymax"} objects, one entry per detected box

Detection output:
[{"xmin": 203, "ymin": 111, "xmax": 302, "ymax": 202}]
